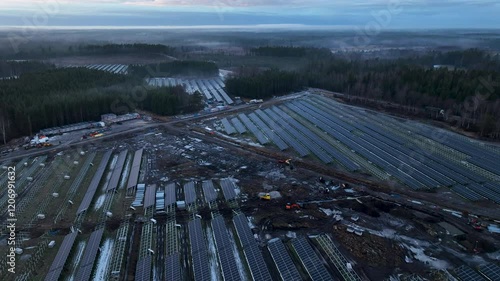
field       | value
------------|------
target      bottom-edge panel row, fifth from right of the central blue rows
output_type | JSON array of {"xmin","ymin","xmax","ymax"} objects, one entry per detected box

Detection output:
[{"xmin": 188, "ymin": 219, "xmax": 210, "ymax": 281}]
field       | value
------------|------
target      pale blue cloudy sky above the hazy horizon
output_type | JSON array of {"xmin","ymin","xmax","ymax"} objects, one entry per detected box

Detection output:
[{"xmin": 0, "ymin": 0, "xmax": 500, "ymax": 29}]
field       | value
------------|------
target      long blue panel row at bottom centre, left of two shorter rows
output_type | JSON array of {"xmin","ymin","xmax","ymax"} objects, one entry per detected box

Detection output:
[{"xmin": 233, "ymin": 214, "xmax": 272, "ymax": 281}]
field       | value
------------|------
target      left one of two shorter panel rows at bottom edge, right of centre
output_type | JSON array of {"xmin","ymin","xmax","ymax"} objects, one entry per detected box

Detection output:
[{"xmin": 267, "ymin": 239, "xmax": 302, "ymax": 281}]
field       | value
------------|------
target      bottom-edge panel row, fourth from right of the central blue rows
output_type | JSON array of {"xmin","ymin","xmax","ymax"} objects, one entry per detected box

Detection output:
[{"xmin": 212, "ymin": 216, "xmax": 240, "ymax": 281}]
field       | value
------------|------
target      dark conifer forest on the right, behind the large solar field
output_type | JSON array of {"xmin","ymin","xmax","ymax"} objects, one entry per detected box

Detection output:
[{"xmin": 226, "ymin": 50, "xmax": 500, "ymax": 138}]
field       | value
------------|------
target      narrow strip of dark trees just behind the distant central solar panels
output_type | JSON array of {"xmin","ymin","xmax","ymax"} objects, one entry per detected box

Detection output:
[{"xmin": 128, "ymin": 60, "xmax": 219, "ymax": 78}]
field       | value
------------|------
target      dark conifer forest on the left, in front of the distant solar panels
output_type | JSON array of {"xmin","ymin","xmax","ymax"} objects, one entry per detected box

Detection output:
[{"xmin": 0, "ymin": 68, "xmax": 201, "ymax": 143}]
